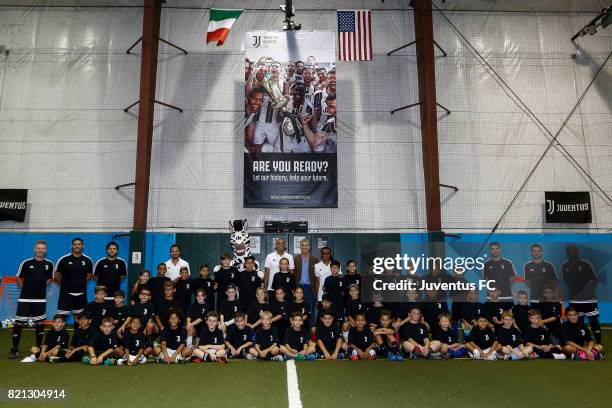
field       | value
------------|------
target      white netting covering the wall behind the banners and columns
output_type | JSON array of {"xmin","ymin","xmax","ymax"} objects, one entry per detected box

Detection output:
[{"xmin": 0, "ymin": 0, "xmax": 612, "ymax": 231}]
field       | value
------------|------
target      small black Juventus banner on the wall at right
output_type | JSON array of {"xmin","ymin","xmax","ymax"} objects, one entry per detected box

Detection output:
[{"xmin": 545, "ymin": 191, "xmax": 592, "ymax": 224}]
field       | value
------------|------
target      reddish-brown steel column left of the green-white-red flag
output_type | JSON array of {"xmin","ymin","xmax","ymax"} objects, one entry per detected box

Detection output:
[{"xmin": 133, "ymin": 0, "xmax": 161, "ymax": 230}]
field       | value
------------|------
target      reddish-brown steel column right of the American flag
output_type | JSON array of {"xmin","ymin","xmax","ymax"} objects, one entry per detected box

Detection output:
[{"xmin": 412, "ymin": 0, "xmax": 443, "ymax": 254}]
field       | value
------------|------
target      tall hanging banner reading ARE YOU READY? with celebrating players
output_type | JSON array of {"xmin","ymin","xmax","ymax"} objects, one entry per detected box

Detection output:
[{"xmin": 244, "ymin": 31, "xmax": 338, "ymax": 208}]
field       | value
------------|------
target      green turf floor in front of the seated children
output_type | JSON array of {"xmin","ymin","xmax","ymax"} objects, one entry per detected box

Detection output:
[{"xmin": 0, "ymin": 330, "xmax": 612, "ymax": 408}]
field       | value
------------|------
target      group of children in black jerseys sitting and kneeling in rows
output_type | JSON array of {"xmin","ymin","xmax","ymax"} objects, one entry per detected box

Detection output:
[{"xmin": 23, "ymin": 255, "xmax": 603, "ymax": 366}]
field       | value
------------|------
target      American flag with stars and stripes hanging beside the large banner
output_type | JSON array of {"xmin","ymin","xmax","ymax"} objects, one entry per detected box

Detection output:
[{"xmin": 338, "ymin": 10, "xmax": 372, "ymax": 61}]
